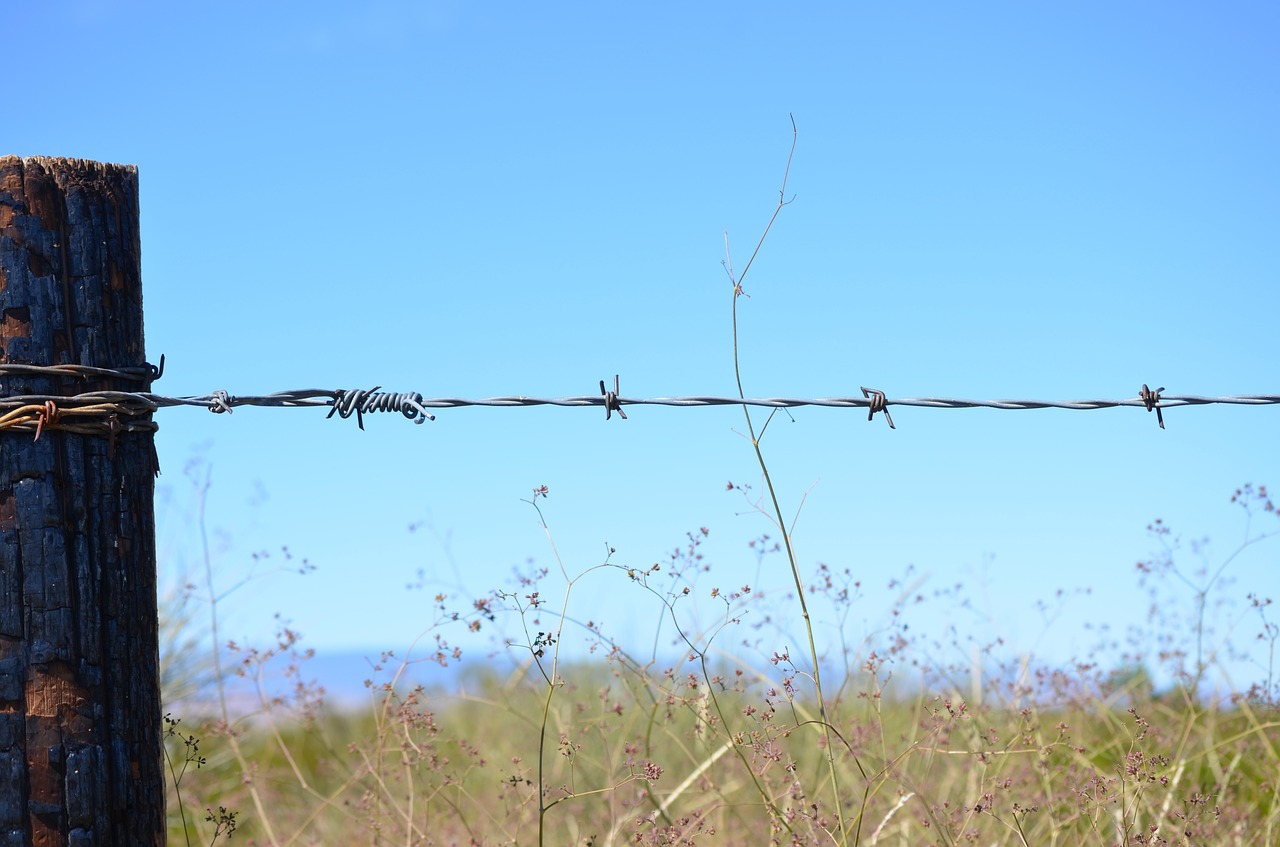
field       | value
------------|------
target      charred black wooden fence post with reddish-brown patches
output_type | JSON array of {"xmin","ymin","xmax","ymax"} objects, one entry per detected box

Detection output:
[{"xmin": 0, "ymin": 156, "xmax": 165, "ymax": 847}]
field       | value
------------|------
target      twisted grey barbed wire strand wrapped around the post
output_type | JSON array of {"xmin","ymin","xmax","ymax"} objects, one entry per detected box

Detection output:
[{"xmin": 0, "ymin": 357, "xmax": 1280, "ymax": 440}]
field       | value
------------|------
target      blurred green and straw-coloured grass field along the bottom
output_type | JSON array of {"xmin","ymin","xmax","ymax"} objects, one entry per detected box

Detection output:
[{"xmin": 162, "ymin": 621, "xmax": 1280, "ymax": 844}]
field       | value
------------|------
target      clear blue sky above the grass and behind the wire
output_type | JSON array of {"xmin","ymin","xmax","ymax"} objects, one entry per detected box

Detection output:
[{"xmin": 0, "ymin": 0, "xmax": 1280, "ymax": 696}]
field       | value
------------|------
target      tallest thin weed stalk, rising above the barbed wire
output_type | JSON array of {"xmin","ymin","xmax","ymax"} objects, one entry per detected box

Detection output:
[{"xmin": 724, "ymin": 116, "xmax": 861, "ymax": 844}]
